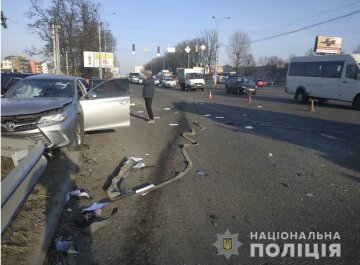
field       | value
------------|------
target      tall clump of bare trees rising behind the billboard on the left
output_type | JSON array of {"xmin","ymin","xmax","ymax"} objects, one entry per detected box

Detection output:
[{"xmin": 26, "ymin": 0, "xmax": 116, "ymax": 75}]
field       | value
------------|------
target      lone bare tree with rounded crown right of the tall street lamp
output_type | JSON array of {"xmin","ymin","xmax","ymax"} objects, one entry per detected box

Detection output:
[{"xmin": 227, "ymin": 31, "xmax": 251, "ymax": 72}]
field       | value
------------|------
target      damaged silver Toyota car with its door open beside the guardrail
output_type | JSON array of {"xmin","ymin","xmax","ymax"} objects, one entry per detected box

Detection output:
[{"xmin": 1, "ymin": 74, "xmax": 130, "ymax": 149}]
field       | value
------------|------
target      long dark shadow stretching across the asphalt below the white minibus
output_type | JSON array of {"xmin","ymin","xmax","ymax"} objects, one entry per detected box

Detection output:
[{"xmin": 174, "ymin": 102, "xmax": 360, "ymax": 177}]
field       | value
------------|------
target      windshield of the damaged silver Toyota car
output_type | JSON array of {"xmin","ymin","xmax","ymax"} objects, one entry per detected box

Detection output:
[{"xmin": 5, "ymin": 79, "xmax": 73, "ymax": 98}]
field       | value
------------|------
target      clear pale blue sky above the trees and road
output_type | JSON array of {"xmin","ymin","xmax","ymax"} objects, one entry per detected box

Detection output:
[{"xmin": 1, "ymin": 0, "xmax": 360, "ymax": 73}]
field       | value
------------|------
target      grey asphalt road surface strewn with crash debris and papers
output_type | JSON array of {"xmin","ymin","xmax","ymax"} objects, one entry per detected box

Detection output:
[{"xmin": 47, "ymin": 85, "xmax": 360, "ymax": 264}]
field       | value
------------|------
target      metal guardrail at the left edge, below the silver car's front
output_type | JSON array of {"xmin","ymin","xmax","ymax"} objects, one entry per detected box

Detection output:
[{"xmin": 1, "ymin": 138, "xmax": 47, "ymax": 233}]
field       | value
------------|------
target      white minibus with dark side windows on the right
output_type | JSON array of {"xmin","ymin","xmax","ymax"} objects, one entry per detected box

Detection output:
[{"xmin": 285, "ymin": 54, "xmax": 360, "ymax": 109}]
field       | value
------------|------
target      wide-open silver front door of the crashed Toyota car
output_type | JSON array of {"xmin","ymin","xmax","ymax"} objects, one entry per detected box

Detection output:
[{"xmin": 80, "ymin": 79, "xmax": 130, "ymax": 131}]
